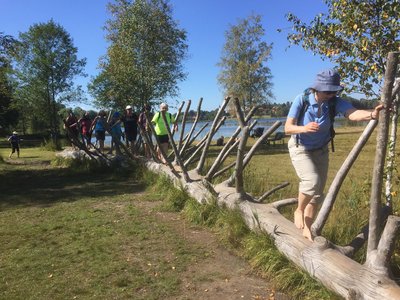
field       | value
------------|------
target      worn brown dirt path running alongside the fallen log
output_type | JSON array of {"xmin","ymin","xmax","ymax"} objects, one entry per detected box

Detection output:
[{"xmin": 136, "ymin": 202, "xmax": 290, "ymax": 300}]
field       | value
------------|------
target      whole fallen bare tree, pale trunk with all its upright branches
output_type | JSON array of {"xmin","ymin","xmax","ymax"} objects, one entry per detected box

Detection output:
[{"xmin": 66, "ymin": 53, "xmax": 400, "ymax": 300}]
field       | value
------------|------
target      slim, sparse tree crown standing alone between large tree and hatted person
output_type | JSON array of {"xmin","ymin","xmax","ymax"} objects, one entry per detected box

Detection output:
[{"xmin": 218, "ymin": 15, "xmax": 272, "ymax": 110}]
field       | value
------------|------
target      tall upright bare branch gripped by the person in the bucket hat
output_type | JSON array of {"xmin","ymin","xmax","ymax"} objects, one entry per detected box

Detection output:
[{"xmin": 367, "ymin": 52, "xmax": 399, "ymax": 260}]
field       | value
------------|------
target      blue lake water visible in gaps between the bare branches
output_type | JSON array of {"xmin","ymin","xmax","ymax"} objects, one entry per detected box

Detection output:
[{"xmin": 103, "ymin": 117, "xmax": 286, "ymax": 145}]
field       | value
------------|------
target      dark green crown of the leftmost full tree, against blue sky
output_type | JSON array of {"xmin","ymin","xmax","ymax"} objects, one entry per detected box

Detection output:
[{"xmin": 15, "ymin": 20, "xmax": 86, "ymax": 137}]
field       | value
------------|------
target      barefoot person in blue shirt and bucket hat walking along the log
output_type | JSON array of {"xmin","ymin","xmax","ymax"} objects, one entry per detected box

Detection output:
[{"xmin": 285, "ymin": 69, "xmax": 383, "ymax": 241}]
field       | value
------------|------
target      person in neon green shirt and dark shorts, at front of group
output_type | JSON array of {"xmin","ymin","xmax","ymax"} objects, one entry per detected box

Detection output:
[{"xmin": 151, "ymin": 103, "xmax": 178, "ymax": 164}]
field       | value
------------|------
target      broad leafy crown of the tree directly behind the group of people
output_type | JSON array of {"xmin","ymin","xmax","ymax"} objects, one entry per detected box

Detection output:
[{"xmin": 89, "ymin": 0, "xmax": 187, "ymax": 109}]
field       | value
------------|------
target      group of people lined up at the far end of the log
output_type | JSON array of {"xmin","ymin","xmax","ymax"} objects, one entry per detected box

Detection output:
[{"xmin": 64, "ymin": 103, "xmax": 177, "ymax": 163}]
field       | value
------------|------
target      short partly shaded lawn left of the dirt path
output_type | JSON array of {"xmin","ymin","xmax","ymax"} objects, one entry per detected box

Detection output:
[{"xmin": 0, "ymin": 149, "xmax": 203, "ymax": 299}]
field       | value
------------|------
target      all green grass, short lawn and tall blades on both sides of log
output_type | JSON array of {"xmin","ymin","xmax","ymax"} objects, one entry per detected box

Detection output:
[{"xmin": 0, "ymin": 127, "xmax": 400, "ymax": 299}]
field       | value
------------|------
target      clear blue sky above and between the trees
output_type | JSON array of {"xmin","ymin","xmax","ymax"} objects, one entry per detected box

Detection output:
[{"xmin": 0, "ymin": 0, "xmax": 334, "ymax": 110}]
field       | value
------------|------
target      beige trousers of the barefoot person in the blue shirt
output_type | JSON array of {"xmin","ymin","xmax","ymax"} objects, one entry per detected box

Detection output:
[{"xmin": 288, "ymin": 137, "xmax": 329, "ymax": 203}]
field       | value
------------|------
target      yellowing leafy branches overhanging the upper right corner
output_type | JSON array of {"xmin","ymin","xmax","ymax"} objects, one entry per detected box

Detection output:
[{"xmin": 287, "ymin": 0, "xmax": 400, "ymax": 96}]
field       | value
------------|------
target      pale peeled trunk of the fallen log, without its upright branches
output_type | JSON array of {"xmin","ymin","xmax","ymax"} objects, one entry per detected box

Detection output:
[{"xmin": 146, "ymin": 161, "xmax": 400, "ymax": 300}]
